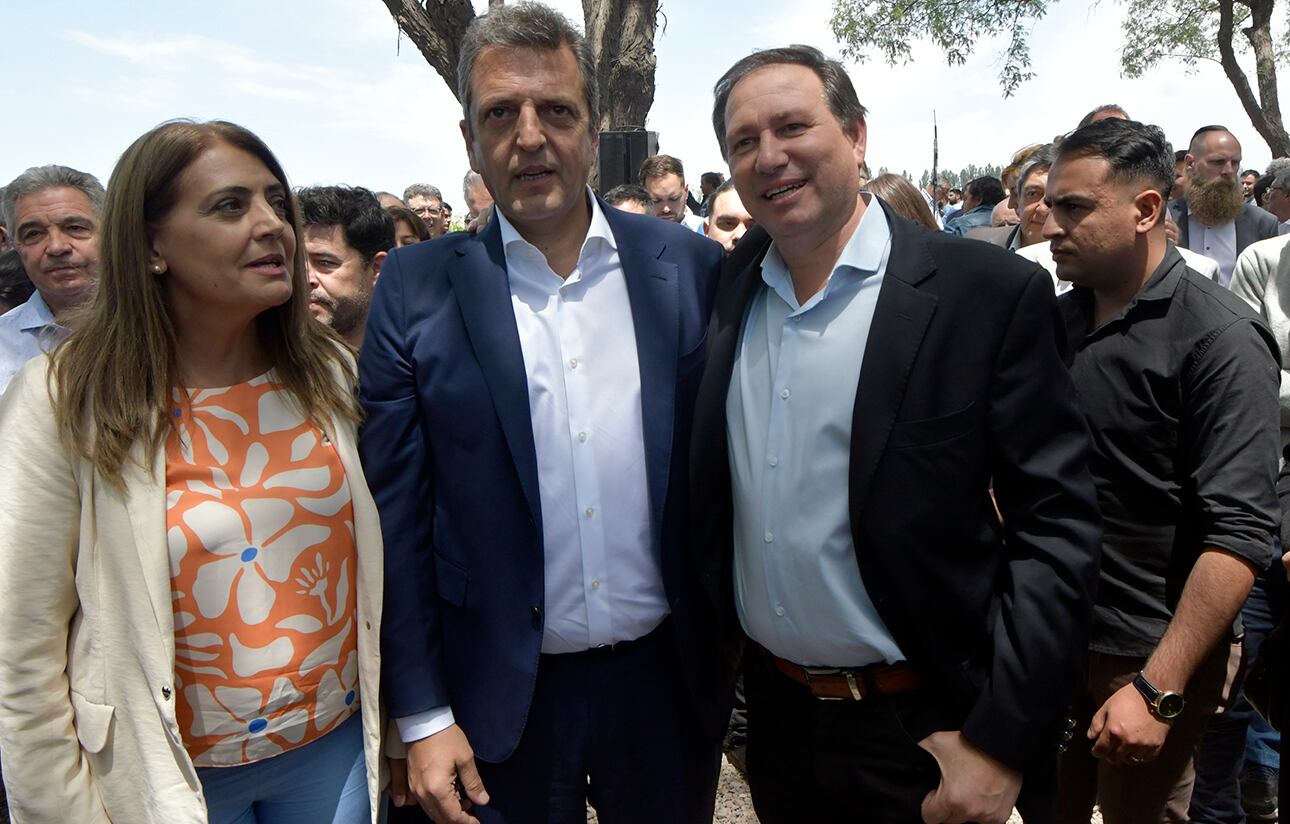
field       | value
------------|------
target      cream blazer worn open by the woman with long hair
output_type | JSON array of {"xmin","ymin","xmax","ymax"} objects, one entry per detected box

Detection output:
[{"xmin": 0, "ymin": 356, "xmax": 386, "ymax": 824}]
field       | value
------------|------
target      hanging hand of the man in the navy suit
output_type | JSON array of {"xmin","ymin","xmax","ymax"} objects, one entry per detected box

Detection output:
[{"xmin": 408, "ymin": 723, "xmax": 488, "ymax": 824}]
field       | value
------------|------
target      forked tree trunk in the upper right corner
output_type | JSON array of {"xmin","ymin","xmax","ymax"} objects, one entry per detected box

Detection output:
[{"xmin": 1218, "ymin": 0, "xmax": 1290, "ymax": 157}]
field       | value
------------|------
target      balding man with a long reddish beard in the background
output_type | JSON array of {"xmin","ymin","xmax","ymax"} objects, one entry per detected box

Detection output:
[{"xmin": 1169, "ymin": 126, "xmax": 1277, "ymax": 286}]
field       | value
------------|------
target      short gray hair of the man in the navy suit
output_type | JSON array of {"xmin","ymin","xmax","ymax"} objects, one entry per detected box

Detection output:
[{"xmin": 457, "ymin": 3, "xmax": 600, "ymax": 133}]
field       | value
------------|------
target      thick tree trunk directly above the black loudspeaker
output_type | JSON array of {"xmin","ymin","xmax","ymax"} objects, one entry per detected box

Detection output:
[{"xmin": 582, "ymin": 0, "xmax": 658, "ymax": 132}]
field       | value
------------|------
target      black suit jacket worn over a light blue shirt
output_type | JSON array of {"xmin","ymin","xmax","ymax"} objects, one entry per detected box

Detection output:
[{"xmin": 690, "ymin": 200, "xmax": 1100, "ymax": 770}]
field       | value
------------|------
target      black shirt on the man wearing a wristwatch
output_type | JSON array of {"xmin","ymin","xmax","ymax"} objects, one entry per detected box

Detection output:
[{"xmin": 1059, "ymin": 245, "xmax": 1281, "ymax": 656}]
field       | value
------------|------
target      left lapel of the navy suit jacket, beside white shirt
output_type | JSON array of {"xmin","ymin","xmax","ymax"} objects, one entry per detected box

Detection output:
[{"xmin": 448, "ymin": 222, "xmax": 542, "ymax": 533}]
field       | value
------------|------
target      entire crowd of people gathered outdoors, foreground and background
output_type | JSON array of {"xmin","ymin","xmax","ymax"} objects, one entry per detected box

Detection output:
[{"xmin": 0, "ymin": 3, "xmax": 1290, "ymax": 824}]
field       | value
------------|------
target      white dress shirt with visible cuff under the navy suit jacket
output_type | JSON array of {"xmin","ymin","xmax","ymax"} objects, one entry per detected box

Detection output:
[{"xmin": 396, "ymin": 193, "xmax": 668, "ymax": 741}]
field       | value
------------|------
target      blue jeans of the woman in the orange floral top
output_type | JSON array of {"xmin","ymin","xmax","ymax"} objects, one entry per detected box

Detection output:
[{"xmin": 197, "ymin": 712, "xmax": 370, "ymax": 824}]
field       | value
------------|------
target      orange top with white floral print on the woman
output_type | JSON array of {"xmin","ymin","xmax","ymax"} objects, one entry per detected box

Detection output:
[{"xmin": 165, "ymin": 373, "xmax": 359, "ymax": 766}]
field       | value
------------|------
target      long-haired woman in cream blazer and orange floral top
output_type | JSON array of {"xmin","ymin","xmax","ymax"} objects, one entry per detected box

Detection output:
[{"xmin": 0, "ymin": 121, "xmax": 382, "ymax": 824}]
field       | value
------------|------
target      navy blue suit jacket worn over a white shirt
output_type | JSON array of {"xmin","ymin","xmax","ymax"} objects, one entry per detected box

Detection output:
[{"xmin": 359, "ymin": 201, "xmax": 725, "ymax": 762}]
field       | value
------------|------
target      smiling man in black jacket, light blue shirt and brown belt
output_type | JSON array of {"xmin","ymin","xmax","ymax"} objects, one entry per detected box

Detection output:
[{"xmin": 690, "ymin": 46, "xmax": 1099, "ymax": 824}]
